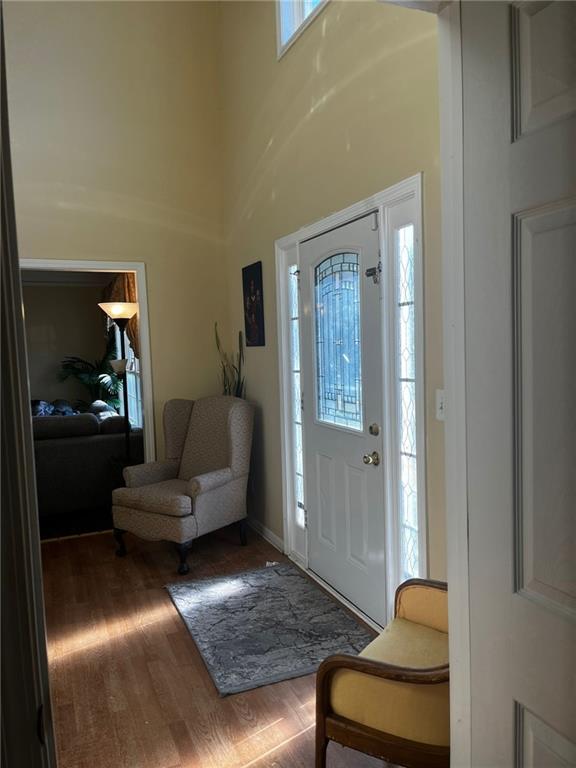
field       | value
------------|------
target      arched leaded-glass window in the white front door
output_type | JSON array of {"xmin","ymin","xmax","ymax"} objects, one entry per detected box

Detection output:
[{"xmin": 314, "ymin": 253, "xmax": 363, "ymax": 431}]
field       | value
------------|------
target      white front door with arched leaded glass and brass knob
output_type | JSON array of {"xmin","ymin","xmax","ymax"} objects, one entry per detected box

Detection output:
[{"xmin": 300, "ymin": 213, "xmax": 386, "ymax": 624}]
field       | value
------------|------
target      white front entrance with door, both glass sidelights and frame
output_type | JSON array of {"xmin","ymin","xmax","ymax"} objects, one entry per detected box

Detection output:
[{"xmin": 276, "ymin": 175, "xmax": 427, "ymax": 626}]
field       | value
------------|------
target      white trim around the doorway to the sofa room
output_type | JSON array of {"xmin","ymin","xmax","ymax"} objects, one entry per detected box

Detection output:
[{"xmin": 20, "ymin": 259, "xmax": 156, "ymax": 461}]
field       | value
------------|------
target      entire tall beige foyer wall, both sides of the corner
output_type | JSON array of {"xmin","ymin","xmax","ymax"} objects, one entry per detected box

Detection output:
[{"xmin": 5, "ymin": 0, "xmax": 445, "ymax": 576}]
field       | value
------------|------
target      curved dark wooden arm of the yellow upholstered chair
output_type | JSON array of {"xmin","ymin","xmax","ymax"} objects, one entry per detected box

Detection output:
[{"xmin": 316, "ymin": 654, "xmax": 450, "ymax": 722}]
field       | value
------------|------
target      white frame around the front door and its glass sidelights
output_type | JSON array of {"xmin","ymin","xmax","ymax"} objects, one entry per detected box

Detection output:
[{"xmin": 275, "ymin": 173, "xmax": 428, "ymax": 626}]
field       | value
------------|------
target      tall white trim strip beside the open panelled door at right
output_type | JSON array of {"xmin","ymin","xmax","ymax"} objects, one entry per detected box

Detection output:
[{"xmin": 438, "ymin": 3, "xmax": 472, "ymax": 768}]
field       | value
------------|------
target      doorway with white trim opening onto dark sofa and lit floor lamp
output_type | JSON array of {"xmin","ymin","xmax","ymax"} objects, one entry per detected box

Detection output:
[{"xmin": 20, "ymin": 259, "xmax": 154, "ymax": 539}]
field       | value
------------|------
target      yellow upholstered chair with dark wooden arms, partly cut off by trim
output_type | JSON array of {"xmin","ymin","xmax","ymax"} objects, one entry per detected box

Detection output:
[{"xmin": 316, "ymin": 579, "xmax": 450, "ymax": 768}]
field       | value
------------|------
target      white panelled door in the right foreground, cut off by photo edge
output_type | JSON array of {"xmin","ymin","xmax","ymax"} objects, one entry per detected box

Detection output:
[{"xmin": 464, "ymin": 2, "xmax": 576, "ymax": 768}]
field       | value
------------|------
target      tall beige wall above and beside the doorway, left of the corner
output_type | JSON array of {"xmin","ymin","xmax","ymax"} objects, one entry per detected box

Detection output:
[{"xmin": 4, "ymin": 2, "xmax": 227, "ymax": 452}]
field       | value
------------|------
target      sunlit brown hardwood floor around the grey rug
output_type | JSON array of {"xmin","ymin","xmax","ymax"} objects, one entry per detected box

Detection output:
[{"xmin": 42, "ymin": 529, "xmax": 382, "ymax": 768}]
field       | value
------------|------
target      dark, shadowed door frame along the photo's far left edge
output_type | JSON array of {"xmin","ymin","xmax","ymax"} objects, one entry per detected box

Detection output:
[{"xmin": 0, "ymin": 13, "xmax": 56, "ymax": 768}]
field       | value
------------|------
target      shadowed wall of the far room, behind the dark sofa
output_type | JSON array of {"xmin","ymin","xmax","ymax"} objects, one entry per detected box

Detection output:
[{"xmin": 23, "ymin": 285, "xmax": 106, "ymax": 402}]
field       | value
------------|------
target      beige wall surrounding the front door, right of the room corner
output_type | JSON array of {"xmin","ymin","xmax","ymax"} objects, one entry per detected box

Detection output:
[{"xmin": 221, "ymin": 2, "xmax": 445, "ymax": 577}]
